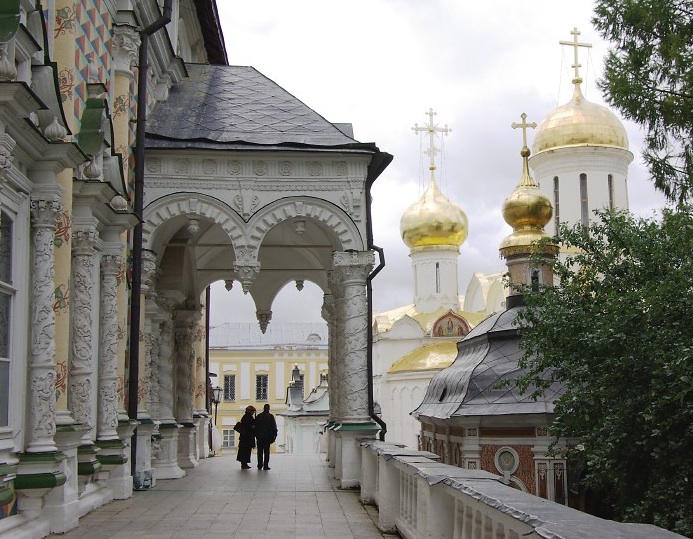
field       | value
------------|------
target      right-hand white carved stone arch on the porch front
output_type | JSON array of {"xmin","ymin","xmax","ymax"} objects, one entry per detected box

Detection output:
[{"xmin": 246, "ymin": 196, "xmax": 366, "ymax": 252}]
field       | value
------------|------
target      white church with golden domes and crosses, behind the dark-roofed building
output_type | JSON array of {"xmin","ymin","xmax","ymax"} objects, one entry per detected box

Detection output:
[{"xmin": 373, "ymin": 29, "xmax": 633, "ymax": 456}]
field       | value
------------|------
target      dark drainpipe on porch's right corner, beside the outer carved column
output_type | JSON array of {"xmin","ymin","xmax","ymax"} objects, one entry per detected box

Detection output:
[{"xmin": 366, "ymin": 152, "xmax": 393, "ymax": 442}]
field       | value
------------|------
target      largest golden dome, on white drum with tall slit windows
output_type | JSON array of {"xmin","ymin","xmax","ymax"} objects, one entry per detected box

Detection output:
[{"xmin": 532, "ymin": 78, "xmax": 628, "ymax": 155}]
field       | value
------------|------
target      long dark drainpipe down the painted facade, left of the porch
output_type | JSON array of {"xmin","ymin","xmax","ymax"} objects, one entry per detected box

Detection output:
[{"xmin": 128, "ymin": 0, "xmax": 173, "ymax": 476}]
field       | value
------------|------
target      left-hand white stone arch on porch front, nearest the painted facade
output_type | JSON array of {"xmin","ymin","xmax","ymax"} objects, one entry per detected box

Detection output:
[{"xmin": 142, "ymin": 192, "xmax": 245, "ymax": 254}]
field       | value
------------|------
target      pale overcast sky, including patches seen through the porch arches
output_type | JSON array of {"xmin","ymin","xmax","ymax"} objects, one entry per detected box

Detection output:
[{"xmin": 211, "ymin": 0, "xmax": 664, "ymax": 326}]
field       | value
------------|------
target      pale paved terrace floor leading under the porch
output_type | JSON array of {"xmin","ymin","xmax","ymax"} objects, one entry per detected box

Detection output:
[{"xmin": 49, "ymin": 453, "xmax": 393, "ymax": 539}]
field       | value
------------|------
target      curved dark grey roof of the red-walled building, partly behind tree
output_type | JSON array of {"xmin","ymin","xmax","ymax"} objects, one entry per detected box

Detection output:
[{"xmin": 412, "ymin": 307, "xmax": 561, "ymax": 419}]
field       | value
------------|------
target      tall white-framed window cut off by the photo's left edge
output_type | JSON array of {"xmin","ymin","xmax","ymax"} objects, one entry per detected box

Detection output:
[{"xmin": 0, "ymin": 212, "xmax": 14, "ymax": 427}]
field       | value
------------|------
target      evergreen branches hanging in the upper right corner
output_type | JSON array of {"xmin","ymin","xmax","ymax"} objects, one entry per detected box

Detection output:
[{"xmin": 592, "ymin": 0, "xmax": 693, "ymax": 203}]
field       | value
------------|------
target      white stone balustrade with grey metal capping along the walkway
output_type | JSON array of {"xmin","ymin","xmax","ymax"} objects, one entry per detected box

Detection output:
[{"xmin": 361, "ymin": 440, "xmax": 685, "ymax": 539}]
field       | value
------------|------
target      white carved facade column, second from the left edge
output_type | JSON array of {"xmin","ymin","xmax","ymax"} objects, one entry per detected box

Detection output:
[{"xmin": 68, "ymin": 229, "xmax": 98, "ymax": 445}]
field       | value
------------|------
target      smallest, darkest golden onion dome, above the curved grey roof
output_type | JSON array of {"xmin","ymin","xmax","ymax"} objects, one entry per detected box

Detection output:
[{"xmin": 500, "ymin": 146, "xmax": 553, "ymax": 253}]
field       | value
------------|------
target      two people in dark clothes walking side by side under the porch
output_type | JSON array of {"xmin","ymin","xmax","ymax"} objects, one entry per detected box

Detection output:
[{"xmin": 234, "ymin": 404, "xmax": 277, "ymax": 470}]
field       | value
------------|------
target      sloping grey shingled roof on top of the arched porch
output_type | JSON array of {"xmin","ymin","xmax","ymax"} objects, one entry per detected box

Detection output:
[{"xmin": 146, "ymin": 64, "xmax": 378, "ymax": 152}]
